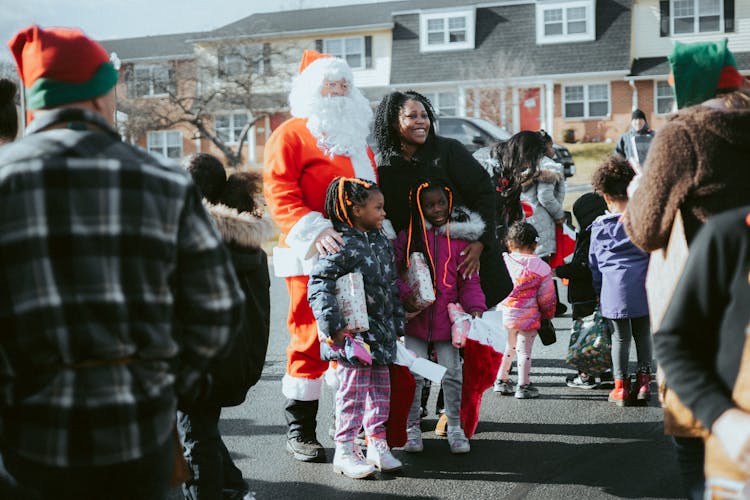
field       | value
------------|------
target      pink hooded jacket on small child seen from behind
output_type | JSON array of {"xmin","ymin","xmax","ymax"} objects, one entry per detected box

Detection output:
[{"xmin": 500, "ymin": 252, "xmax": 557, "ymax": 331}]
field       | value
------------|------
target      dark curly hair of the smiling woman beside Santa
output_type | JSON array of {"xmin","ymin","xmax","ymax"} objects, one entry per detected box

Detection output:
[{"xmin": 373, "ymin": 90, "xmax": 435, "ymax": 158}]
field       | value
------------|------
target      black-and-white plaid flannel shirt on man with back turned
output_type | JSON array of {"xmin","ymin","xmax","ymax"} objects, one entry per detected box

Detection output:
[{"xmin": 0, "ymin": 110, "xmax": 243, "ymax": 467}]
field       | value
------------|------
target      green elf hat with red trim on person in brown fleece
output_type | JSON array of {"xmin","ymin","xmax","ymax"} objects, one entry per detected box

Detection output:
[{"xmin": 669, "ymin": 38, "xmax": 742, "ymax": 109}]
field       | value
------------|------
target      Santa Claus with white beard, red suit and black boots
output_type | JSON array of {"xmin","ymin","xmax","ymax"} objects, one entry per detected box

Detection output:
[{"xmin": 263, "ymin": 50, "xmax": 376, "ymax": 462}]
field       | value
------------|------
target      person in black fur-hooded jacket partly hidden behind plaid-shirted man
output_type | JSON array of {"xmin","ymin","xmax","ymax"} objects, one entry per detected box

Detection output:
[{"xmin": 182, "ymin": 153, "xmax": 273, "ymax": 499}]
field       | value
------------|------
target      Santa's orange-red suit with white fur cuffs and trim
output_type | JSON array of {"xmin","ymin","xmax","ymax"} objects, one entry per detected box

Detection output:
[{"xmin": 263, "ymin": 118, "xmax": 382, "ymax": 401}]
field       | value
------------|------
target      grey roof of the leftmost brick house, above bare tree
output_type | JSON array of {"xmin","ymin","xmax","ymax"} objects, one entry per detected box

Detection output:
[{"xmin": 99, "ymin": 31, "xmax": 205, "ymax": 62}]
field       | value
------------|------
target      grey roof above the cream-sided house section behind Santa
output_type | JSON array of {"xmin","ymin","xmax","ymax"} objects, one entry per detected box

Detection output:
[{"xmin": 204, "ymin": 0, "xmax": 476, "ymax": 40}]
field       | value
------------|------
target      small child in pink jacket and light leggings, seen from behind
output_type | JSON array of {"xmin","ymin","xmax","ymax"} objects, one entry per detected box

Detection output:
[{"xmin": 495, "ymin": 222, "xmax": 557, "ymax": 399}]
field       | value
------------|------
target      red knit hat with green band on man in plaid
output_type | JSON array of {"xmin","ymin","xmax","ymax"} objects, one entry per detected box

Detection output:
[{"xmin": 8, "ymin": 26, "xmax": 117, "ymax": 109}]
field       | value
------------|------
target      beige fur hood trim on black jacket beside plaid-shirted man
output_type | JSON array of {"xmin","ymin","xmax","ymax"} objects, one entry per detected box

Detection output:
[{"xmin": 203, "ymin": 199, "xmax": 274, "ymax": 248}]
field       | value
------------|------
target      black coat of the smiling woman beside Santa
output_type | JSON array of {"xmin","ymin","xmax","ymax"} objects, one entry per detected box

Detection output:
[{"xmin": 377, "ymin": 135, "xmax": 513, "ymax": 307}]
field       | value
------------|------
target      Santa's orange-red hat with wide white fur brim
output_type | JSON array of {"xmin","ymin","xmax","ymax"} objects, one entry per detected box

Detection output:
[{"xmin": 289, "ymin": 50, "xmax": 354, "ymax": 117}]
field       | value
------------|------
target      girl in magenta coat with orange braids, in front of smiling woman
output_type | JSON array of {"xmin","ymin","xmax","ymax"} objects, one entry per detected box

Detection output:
[{"xmin": 395, "ymin": 181, "xmax": 486, "ymax": 453}]
